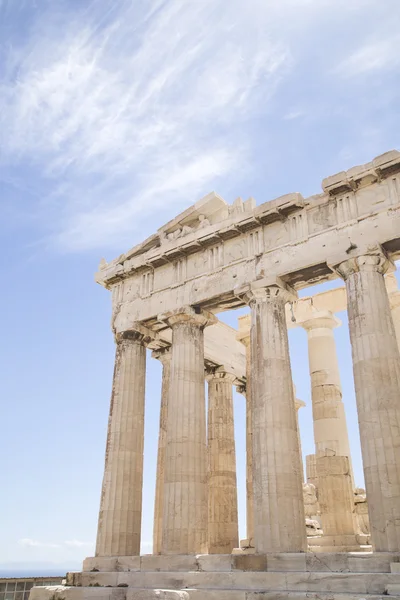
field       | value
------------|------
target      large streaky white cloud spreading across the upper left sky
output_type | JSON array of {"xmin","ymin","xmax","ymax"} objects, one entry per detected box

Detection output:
[{"xmin": 0, "ymin": 0, "xmax": 394, "ymax": 250}]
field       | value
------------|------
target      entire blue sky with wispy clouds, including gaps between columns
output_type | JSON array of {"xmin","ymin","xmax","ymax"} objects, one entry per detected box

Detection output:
[{"xmin": 0, "ymin": 0, "xmax": 400, "ymax": 569}]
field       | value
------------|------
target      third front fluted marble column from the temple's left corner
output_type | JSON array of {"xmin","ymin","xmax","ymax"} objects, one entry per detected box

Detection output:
[{"xmin": 247, "ymin": 280, "xmax": 307, "ymax": 553}]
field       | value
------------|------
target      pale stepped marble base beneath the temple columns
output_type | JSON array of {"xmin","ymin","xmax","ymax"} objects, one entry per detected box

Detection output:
[{"xmin": 32, "ymin": 553, "xmax": 400, "ymax": 600}]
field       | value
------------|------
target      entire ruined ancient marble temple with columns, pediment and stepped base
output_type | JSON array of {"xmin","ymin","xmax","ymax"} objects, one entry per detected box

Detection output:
[{"xmin": 32, "ymin": 151, "xmax": 400, "ymax": 600}]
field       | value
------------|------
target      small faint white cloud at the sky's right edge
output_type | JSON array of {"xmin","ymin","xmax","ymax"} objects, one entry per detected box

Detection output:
[{"xmin": 336, "ymin": 34, "xmax": 400, "ymax": 77}]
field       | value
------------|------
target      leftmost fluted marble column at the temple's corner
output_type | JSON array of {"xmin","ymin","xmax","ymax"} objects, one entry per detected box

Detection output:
[{"xmin": 96, "ymin": 331, "xmax": 146, "ymax": 556}]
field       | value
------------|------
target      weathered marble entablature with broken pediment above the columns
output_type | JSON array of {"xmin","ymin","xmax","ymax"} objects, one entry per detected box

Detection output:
[{"xmin": 96, "ymin": 151, "xmax": 400, "ymax": 328}]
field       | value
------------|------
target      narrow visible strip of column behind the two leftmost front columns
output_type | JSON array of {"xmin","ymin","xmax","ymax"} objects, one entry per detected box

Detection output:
[{"xmin": 152, "ymin": 348, "xmax": 171, "ymax": 554}]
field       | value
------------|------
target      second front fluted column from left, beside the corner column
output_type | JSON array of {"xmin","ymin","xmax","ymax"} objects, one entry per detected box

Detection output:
[{"xmin": 159, "ymin": 307, "xmax": 216, "ymax": 554}]
